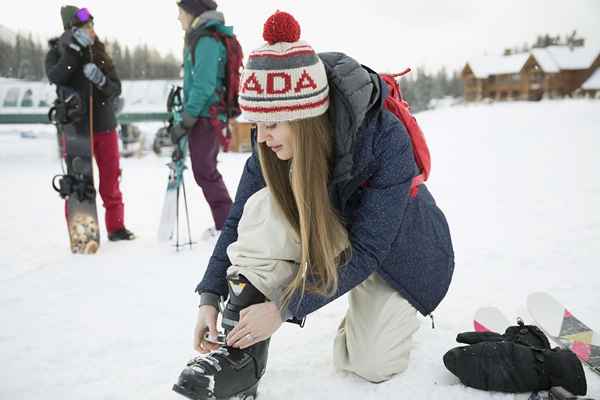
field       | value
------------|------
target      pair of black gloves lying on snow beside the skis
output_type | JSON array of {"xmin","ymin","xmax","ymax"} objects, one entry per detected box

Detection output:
[{"xmin": 444, "ymin": 320, "xmax": 587, "ymax": 395}]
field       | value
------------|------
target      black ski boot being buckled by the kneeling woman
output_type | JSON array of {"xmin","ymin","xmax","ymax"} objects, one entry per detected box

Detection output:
[{"xmin": 173, "ymin": 276, "xmax": 269, "ymax": 400}]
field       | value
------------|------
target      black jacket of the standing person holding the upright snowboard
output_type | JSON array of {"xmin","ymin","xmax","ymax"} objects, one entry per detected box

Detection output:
[{"xmin": 46, "ymin": 32, "xmax": 121, "ymax": 133}]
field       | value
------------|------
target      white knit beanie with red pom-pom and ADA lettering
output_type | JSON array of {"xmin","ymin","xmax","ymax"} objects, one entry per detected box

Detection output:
[{"xmin": 239, "ymin": 11, "xmax": 329, "ymax": 122}]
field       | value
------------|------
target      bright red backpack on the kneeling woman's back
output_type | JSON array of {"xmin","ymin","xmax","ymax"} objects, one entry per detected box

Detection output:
[{"xmin": 379, "ymin": 68, "xmax": 431, "ymax": 197}]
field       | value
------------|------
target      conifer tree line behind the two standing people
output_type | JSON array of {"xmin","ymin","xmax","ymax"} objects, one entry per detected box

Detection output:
[{"xmin": 0, "ymin": 34, "xmax": 181, "ymax": 81}]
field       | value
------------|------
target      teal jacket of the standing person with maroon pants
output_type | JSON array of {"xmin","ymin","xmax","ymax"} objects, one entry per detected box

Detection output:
[{"xmin": 183, "ymin": 12, "xmax": 233, "ymax": 121}]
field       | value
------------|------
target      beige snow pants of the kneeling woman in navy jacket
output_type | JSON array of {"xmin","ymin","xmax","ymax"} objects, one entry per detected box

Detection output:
[{"xmin": 227, "ymin": 188, "xmax": 419, "ymax": 382}]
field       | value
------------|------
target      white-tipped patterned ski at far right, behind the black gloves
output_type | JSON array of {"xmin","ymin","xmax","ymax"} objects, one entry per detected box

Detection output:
[{"xmin": 527, "ymin": 292, "xmax": 600, "ymax": 375}]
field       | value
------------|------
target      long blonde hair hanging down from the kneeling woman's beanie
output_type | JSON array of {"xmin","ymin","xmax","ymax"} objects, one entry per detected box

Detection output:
[{"xmin": 258, "ymin": 114, "xmax": 349, "ymax": 306}]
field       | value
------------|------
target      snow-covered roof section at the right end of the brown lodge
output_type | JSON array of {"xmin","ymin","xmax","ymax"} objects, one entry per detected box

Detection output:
[{"xmin": 531, "ymin": 46, "xmax": 600, "ymax": 73}]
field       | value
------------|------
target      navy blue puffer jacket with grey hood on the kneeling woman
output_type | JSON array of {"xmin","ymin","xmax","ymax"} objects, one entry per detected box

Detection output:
[{"xmin": 196, "ymin": 53, "xmax": 454, "ymax": 318}]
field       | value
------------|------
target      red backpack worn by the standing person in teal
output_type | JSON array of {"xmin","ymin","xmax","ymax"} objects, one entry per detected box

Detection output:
[{"xmin": 191, "ymin": 29, "xmax": 244, "ymax": 152}]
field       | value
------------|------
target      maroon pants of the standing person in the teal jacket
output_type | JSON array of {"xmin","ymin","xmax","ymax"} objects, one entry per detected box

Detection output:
[{"xmin": 189, "ymin": 118, "xmax": 231, "ymax": 230}]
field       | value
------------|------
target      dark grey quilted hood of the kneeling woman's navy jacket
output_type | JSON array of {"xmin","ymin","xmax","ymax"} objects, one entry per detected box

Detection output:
[{"xmin": 319, "ymin": 53, "xmax": 387, "ymax": 204}]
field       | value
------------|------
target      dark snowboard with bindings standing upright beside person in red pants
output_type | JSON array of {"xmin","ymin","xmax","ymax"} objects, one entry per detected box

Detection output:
[{"xmin": 49, "ymin": 88, "xmax": 100, "ymax": 254}]
